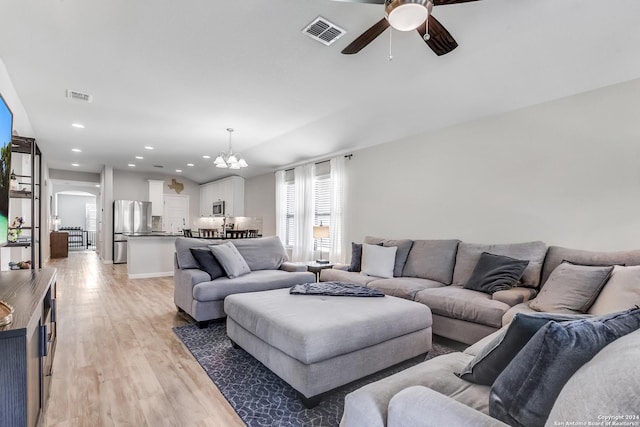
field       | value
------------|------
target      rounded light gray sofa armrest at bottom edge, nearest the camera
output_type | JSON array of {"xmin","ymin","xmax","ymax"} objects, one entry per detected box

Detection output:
[{"xmin": 387, "ymin": 386, "xmax": 508, "ymax": 427}]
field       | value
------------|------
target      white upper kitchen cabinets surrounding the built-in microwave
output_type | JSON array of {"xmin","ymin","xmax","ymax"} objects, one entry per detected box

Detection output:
[{"xmin": 200, "ymin": 176, "xmax": 244, "ymax": 216}]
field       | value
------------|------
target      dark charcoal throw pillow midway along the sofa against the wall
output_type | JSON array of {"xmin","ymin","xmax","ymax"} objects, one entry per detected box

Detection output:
[{"xmin": 464, "ymin": 252, "xmax": 529, "ymax": 294}]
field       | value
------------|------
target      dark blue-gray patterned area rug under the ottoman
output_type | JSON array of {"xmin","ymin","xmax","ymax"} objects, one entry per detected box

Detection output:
[{"xmin": 173, "ymin": 322, "xmax": 456, "ymax": 427}]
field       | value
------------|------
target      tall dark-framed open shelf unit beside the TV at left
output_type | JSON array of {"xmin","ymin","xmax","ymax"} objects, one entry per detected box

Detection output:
[{"xmin": 6, "ymin": 135, "xmax": 42, "ymax": 268}]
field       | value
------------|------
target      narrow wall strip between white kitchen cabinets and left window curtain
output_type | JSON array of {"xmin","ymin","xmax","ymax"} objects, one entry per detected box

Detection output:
[{"xmin": 244, "ymin": 173, "xmax": 276, "ymax": 236}]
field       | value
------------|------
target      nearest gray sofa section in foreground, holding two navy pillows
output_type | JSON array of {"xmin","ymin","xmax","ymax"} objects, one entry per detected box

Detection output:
[{"xmin": 340, "ymin": 324, "xmax": 640, "ymax": 427}]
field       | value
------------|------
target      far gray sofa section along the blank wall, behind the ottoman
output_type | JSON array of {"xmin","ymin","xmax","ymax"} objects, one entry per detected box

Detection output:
[{"xmin": 320, "ymin": 236, "xmax": 640, "ymax": 344}]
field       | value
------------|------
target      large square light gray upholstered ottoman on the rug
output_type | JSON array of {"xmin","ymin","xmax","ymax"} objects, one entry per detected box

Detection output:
[{"xmin": 224, "ymin": 289, "xmax": 432, "ymax": 407}]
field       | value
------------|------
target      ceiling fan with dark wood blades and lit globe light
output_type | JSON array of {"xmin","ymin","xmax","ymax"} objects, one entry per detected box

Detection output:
[{"xmin": 334, "ymin": 0, "xmax": 478, "ymax": 56}]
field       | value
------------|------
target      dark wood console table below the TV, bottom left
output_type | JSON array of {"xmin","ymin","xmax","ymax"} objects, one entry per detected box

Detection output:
[{"xmin": 0, "ymin": 268, "xmax": 57, "ymax": 427}]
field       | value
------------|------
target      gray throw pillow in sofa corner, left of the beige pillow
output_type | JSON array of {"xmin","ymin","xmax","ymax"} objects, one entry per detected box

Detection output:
[{"xmin": 529, "ymin": 262, "xmax": 613, "ymax": 313}]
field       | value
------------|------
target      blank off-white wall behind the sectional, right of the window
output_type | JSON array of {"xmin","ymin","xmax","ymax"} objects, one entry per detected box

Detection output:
[{"xmin": 346, "ymin": 80, "xmax": 640, "ymax": 250}]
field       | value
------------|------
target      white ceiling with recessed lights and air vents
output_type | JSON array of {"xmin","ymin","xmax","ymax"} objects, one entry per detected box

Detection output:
[{"xmin": 0, "ymin": 0, "xmax": 640, "ymax": 183}]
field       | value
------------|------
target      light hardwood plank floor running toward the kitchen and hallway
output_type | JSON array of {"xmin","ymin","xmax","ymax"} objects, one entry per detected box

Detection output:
[{"xmin": 43, "ymin": 252, "xmax": 244, "ymax": 427}]
